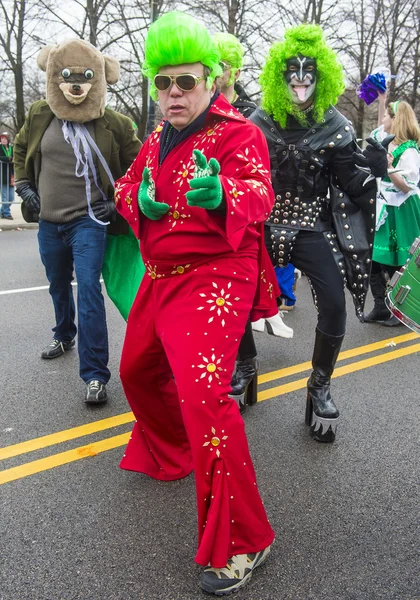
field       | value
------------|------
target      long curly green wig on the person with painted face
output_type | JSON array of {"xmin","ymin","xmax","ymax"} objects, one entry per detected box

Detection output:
[{"xmin": 260, "ymin": 24, "xmax": 345, "ymax": 127}]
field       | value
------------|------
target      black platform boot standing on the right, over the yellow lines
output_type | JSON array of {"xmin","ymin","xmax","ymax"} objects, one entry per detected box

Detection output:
[{"xmin": 305, "ymin": 329, "xmax": 344, "ymax": 442}]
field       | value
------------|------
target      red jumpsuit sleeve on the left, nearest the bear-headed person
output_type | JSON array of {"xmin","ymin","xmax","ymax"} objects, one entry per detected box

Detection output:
[{"xmin": 115, "ymin": 140, "xmax": 148, "ymax": 238}]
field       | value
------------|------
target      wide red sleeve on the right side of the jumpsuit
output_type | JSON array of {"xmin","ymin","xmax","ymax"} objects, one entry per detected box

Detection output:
[{"xmin": 209, "ymin": 121, "xmax": 274, "ymax": 251}]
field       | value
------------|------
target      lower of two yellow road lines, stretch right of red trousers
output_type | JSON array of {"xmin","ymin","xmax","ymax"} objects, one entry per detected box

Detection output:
[{"xmin": 257, "ymin": 344, "xmax": 420, "ymax": 402}]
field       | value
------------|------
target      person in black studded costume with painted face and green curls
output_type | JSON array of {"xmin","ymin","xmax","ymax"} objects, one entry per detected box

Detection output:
[{"xmin": 250, "ymin": 24, "xmax": 387, "ymax": 442}]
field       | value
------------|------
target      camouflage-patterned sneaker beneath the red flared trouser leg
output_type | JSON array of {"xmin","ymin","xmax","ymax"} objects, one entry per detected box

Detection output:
[{"xmin": 200, "ymin": 546, "xmax": 271, "ymax": 596}]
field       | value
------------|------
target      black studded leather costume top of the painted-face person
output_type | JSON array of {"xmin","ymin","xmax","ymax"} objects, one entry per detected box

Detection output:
[{"xmin": 250, "ymin": 106, "xmax": 376, "ymax": 317}]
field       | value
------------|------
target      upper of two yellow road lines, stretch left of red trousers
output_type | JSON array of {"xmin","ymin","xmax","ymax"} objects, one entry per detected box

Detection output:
[{"xmin": 0, "ymin": 412, "xmax": 134, "ymax": 460}]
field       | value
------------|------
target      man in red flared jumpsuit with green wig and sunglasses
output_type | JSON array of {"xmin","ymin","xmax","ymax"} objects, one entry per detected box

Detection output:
[{"xmin": 115, "ymin": 13, "xmax": 274, "ymax": 594}]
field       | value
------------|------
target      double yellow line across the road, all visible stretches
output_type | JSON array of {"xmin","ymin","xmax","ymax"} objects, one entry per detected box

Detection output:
[{"xmin": 0, "ymin": 333, "xmax": 420, "ymax": 485}]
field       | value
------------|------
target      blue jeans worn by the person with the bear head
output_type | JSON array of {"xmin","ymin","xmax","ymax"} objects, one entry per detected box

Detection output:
[{"xmin": 38, "ymin": 215, "xmax": 111, "ymax": 383}]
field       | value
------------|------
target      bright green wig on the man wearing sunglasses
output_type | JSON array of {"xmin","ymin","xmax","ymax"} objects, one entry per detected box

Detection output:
[{"xmin": 142, "ymin": 12, "xmax": 222, "ymax": 100}]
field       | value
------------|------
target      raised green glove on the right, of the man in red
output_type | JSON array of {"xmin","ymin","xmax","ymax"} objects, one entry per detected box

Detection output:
[{"xmin": 186, "ymin": 150, "xmax": 223, "ymax": 210}]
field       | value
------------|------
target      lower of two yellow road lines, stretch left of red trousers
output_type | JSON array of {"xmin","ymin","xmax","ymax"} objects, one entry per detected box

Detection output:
[{"xmin": 0, "ymin": 433, "xmax": 130, "ymax": 485}]
